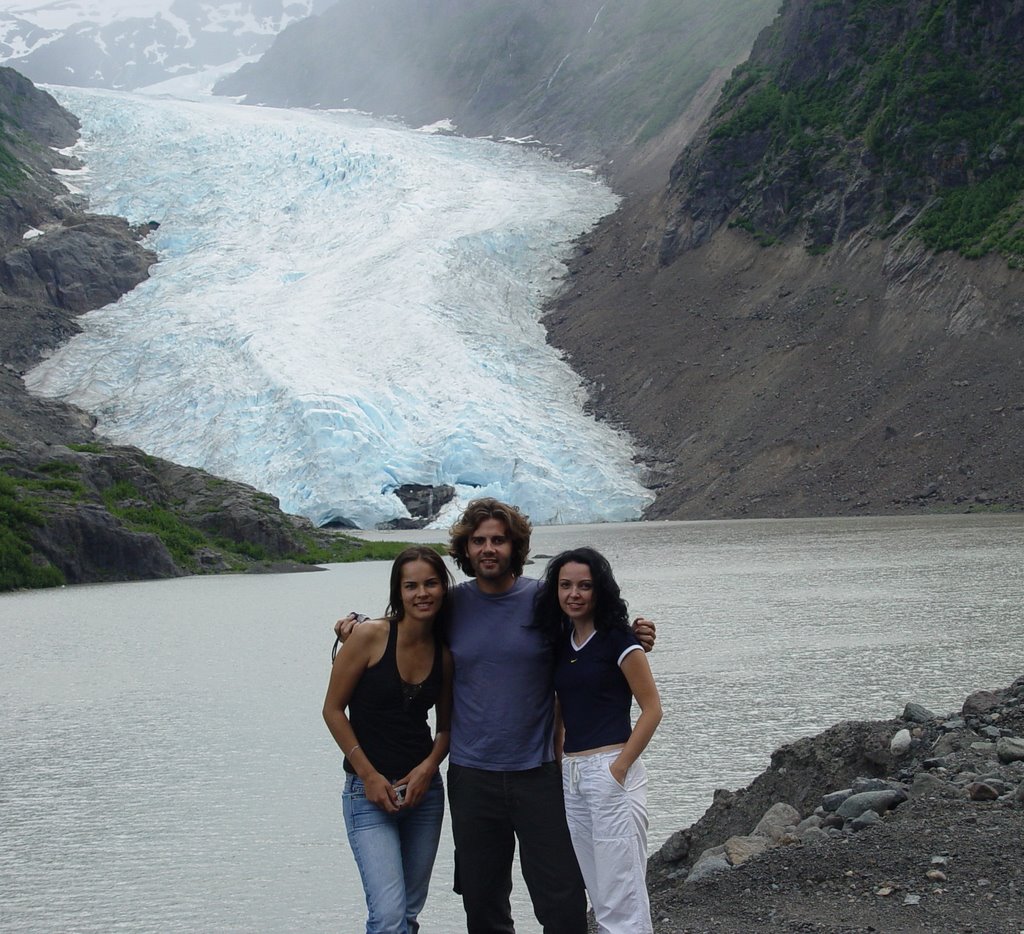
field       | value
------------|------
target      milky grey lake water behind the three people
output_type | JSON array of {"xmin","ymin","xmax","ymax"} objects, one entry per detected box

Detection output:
[{"xmin": 0, "ymin": 516, "xmax": 1024, "ymax": 934}]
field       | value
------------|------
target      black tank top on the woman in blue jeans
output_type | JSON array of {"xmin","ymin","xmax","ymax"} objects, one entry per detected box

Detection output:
[{"xmin": 345, "ymin": 620, "xmax": 443, "ymax": 781}]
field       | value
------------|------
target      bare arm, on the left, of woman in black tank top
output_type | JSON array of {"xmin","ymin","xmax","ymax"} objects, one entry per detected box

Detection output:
[{"xmin": 324, "ymin": 621, "xmax": 398, "ymax": 813}]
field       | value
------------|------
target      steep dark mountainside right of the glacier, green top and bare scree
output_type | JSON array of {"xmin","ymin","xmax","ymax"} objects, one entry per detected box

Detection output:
[{"xmin": 548, "ymin": 0, "xmax": 1024, "ymax": 518}]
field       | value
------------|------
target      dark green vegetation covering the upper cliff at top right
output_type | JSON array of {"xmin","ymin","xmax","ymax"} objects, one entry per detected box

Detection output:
[{"xmin": 710, "ymin": 0, "xmax": 1024, "ymax": 266}]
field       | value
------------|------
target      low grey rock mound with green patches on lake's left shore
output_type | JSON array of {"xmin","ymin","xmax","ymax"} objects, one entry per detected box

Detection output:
[{"xmin": 0, "ymin": 439, "xmax": 314, "ymax": 584}]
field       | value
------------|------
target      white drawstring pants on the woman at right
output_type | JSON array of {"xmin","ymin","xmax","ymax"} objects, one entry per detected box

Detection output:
[{"xmin": 562, "ymin": 750, "xmax": 653, "ymax": 934}]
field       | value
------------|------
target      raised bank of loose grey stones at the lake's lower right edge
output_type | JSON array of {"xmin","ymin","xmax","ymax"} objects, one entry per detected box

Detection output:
[{"xmin": 652, "ymin": 677, "xmax": 1024, "ymax": 881}]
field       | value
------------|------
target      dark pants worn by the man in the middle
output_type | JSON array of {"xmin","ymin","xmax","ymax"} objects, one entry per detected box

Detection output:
[{"xmin": 447, "ymin": 762, "xmax": 587, "ymax": 934}]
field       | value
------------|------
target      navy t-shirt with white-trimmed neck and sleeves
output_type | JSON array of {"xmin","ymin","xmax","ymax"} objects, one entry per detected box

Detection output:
[{"xmin": 555, "ymin": 629, "xmax": 643, "ymax": 753}]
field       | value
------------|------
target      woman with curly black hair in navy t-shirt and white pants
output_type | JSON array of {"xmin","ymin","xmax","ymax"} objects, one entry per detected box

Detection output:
[{"xmin": 536, "ymin": 548, "xmax": 662, "ymax": 934}]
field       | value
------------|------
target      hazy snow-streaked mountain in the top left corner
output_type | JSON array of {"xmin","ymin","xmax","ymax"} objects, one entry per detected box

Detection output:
[{"xmin": 0, "ymin": 0, "xmax": 329, "ymax": 89}]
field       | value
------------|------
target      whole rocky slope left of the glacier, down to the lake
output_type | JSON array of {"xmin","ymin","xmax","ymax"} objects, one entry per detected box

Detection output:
[{"xmin": 0, "ymin": 69, "xmax": 395, "ymax": 591}]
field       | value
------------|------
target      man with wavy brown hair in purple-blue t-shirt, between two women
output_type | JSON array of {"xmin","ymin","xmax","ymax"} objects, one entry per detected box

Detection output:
[{"xmin": 447, "ymin": 499, "xmax": 587, "ymax": 934}]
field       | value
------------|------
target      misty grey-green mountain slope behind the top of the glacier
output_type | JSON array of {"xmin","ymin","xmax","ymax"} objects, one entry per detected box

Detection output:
[{"xmin": 216, "ymin": 0, "xmax": 778, "ymax": 187}]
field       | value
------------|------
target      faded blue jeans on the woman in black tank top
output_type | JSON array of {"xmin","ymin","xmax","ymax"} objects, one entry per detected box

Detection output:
[{"xmin": 342, "ymin": 775, "xmax": 444, "ymax": 934}]
